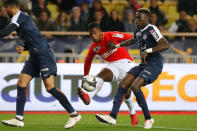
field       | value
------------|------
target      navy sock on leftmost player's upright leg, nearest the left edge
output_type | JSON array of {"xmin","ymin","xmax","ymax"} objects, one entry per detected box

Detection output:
[{"xmin": 16, "ymin": 87, "xmax": 27, "ymax": 116}]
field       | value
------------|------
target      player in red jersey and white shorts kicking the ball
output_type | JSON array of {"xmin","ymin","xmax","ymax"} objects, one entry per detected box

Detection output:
[{"xmin": 78, "ymin": 22, "xmax": 138, "ymax": 126}]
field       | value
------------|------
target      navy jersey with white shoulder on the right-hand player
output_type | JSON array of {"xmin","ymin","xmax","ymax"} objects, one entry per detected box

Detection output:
[{"xmin": 133, "ymin": 24, "xmax": 163, "ymax": 64}]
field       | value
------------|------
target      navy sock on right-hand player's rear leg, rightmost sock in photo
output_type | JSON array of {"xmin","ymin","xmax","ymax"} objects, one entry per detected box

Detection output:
[{"xmin": 134, "ymin": 89, "xmax": 151, "ymax": 120}]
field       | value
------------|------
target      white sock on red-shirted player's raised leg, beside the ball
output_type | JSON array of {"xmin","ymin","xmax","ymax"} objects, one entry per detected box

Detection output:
[{"xmin": 88, "ymin": 77, "xmax": 104, "ymax": 99}]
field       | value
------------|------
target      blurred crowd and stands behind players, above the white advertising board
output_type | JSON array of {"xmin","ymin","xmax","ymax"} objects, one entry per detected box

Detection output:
[{"xmin": 0, "ymin": 0, "xmax": 197, "ymax": 63}]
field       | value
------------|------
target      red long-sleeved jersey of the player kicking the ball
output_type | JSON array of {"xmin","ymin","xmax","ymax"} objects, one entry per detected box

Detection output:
[{"xmin": 84, "ymin": 31, "xmax": 133, "ymax": 75}]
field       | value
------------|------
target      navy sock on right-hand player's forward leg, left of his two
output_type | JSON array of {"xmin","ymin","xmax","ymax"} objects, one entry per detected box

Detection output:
[{"xmin": 110, "ymin": 88, "xmax": 126, "ymax": 119}]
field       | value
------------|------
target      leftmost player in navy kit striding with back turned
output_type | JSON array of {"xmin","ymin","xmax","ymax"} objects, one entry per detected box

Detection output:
[{"xmin": 0, "ymin": 0, "xmax": 81, "ymax": 128}]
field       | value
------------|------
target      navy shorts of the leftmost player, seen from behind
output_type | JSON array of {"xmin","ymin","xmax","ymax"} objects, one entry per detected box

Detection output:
[{"xmin": 21, "ymin": 50, "xmax": 57, "ymax": 80}]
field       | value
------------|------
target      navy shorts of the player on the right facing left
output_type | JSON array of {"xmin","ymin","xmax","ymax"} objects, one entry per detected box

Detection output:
[{"xmin": 128, "ymin": 63, "xmax": 163, "ymax": 85}]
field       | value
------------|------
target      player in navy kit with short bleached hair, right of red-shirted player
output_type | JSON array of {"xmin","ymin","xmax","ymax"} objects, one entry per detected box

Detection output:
[{"xmin": 96, "ymin": 8, "xmax": 169, "ymax": 129}]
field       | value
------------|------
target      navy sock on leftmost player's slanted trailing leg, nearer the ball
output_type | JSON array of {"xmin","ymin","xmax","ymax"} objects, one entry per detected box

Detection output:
[{"xmin": 48, "ymin": 87, "xmax": 75, "ymax": 113}]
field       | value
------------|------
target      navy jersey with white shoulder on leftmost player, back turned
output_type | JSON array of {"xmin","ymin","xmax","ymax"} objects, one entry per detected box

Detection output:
[{"xmin": 10, "ymin": 11, "xmax": 49, "ymax": 54}]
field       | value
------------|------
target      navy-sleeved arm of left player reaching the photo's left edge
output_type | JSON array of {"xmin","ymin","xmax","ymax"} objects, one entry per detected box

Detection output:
[{"xmin": 0, "ymin": 23, "xmax": 18, "ymax": 38}]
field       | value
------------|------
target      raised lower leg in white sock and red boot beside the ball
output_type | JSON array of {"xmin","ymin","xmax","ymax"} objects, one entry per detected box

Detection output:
[{"xmin": 77, "ymin": 77, "xmax": 104, "ymax": 105}]
